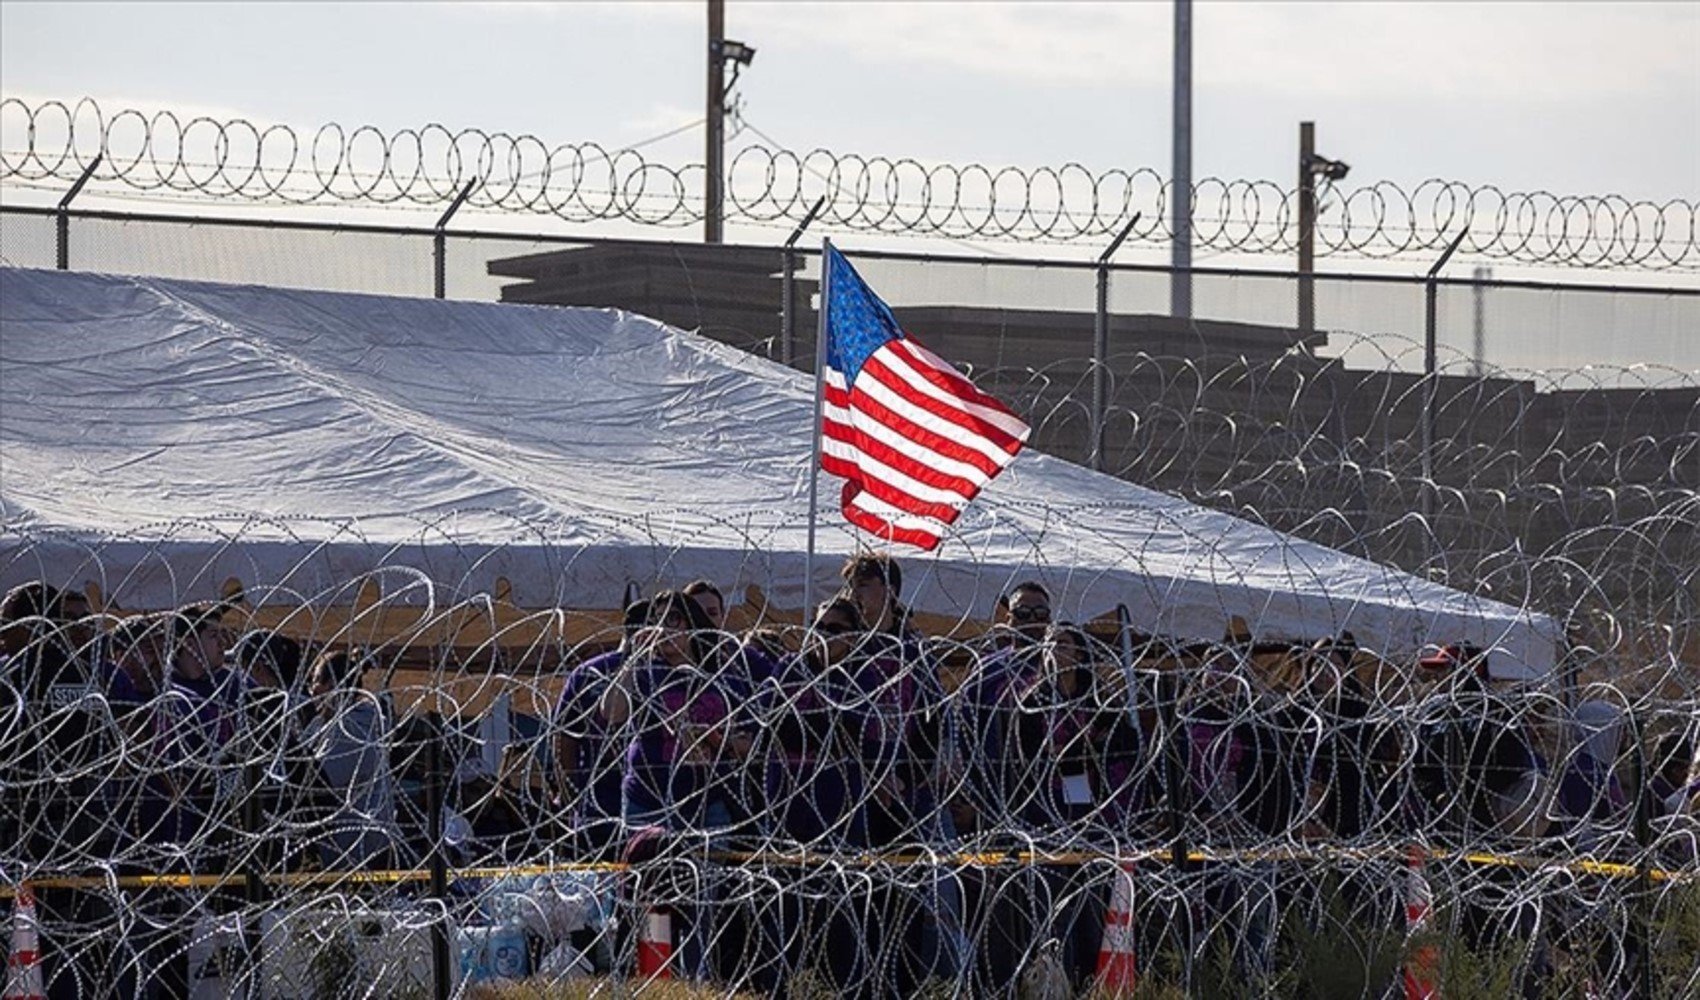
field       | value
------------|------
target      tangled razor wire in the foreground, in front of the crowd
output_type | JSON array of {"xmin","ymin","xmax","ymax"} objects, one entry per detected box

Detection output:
[{"xmin": 0, "ymin": 568, "xmax": 1700, "ymax": 997}]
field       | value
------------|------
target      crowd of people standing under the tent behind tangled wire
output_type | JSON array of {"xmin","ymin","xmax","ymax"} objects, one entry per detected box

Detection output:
[{"xmin": 0, "ymin": 554, "xmax": 1700, "ymax": 995}]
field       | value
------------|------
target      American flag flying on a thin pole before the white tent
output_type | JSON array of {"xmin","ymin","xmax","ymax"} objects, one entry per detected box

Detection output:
[{"xmin": 821, "ymin": 245, "xmax": 1029, "ymax": 549}]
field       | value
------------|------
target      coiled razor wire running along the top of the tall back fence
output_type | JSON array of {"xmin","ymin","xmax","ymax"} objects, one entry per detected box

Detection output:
[{"xmin": 0, "ymin": 99, "xmax": 1697, "ymax": 270}]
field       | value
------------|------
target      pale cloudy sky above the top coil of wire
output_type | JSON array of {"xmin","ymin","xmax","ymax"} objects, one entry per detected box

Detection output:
[{"xmin": 0, "ymin": 0, "xmax": 1700, "ymax": 201}]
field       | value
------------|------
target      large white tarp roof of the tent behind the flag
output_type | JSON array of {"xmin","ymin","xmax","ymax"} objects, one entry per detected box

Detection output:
[{"xmin": 0, "ymin": 269, "xmax": 1559, "ymax": 675}]
